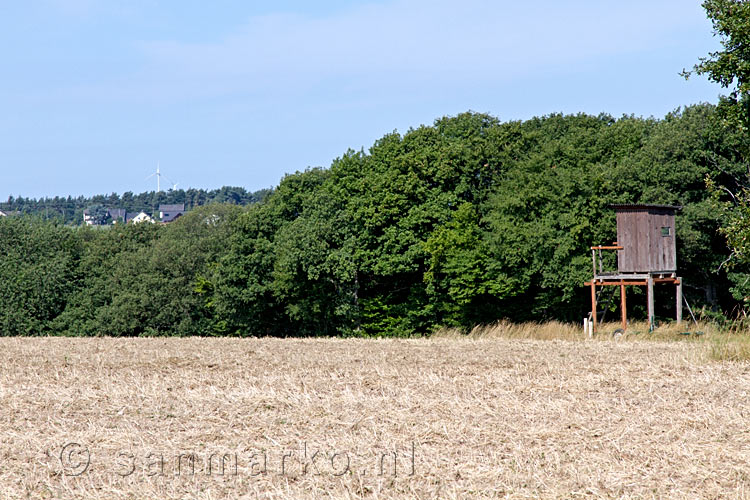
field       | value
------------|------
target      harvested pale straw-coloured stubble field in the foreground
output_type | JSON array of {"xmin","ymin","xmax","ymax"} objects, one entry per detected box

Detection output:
[{"xmin": 0, "ymin": 338, "xmax": 750, "ymax": 499}]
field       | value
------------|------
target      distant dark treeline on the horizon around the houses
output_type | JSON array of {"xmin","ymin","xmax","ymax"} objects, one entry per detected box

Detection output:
[{"xmin": 0, "ymin": 186, "xmax": 270, "ymax": 225}]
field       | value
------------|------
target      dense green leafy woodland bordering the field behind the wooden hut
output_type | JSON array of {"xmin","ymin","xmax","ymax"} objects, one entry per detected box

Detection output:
[{"xmin": 0, "ymin": 104, "xmax": 748, "ymax": 336}]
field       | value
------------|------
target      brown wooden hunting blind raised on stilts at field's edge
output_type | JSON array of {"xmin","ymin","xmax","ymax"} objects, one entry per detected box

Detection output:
[{"xmin": 585, "ymin": 205, "xmax": 682, "ymax": 331}]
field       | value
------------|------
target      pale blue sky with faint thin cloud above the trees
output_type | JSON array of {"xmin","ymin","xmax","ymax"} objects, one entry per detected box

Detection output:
[{"xmin": 0, "ymin": 0, "xmax": 721, "ymax": 199}]
